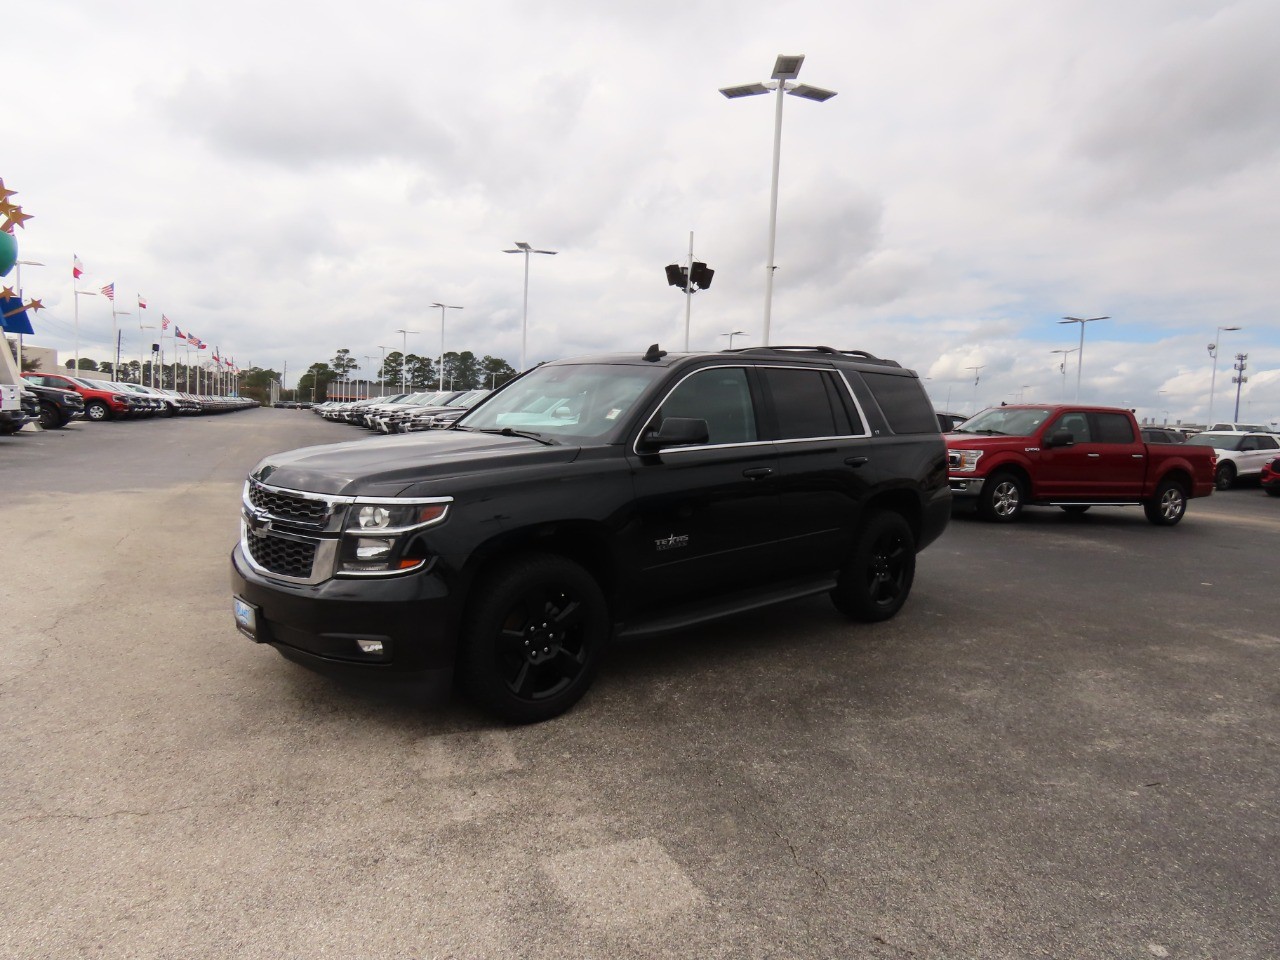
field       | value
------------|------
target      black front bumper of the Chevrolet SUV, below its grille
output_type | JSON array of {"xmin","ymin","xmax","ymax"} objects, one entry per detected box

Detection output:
[{"xmin": 232, "ymin": 544, "xmax": 460, "ymax": 676}]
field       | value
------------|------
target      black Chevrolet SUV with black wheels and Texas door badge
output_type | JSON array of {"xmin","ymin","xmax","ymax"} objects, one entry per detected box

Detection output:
[{"xmin": 232, "ymin": 344, "xmax": 951, "ymax": 722}]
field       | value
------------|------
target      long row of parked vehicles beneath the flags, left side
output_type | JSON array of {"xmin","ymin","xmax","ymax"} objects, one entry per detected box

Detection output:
[{"xmin": 14, "ymin": 371, "xmax": 257, "ymax": 430}]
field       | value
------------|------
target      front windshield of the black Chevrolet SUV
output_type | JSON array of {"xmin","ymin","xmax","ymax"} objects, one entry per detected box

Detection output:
[{"xmin": 458, "ymin": 364, "xmax": 664, "ymax": 439}]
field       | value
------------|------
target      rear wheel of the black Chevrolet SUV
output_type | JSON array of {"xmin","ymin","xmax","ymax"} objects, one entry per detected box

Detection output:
[{"xmin": 831, "ymin": 512, "xmax": 915, "ymax": 623}]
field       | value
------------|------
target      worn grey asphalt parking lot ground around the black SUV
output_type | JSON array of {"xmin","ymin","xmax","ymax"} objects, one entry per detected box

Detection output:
[{"xmin": 0, "ymin": 410, "xmax": 1280, "ymax": 960}]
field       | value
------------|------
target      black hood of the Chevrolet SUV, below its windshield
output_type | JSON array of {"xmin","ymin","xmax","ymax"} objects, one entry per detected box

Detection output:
[{"xmin": 251, "ymin": 430, "xmax": 580, "ymax": 497}]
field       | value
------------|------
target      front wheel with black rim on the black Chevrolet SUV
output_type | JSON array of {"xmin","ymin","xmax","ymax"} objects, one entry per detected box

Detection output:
[{"xmin": 458, "ymin": 554, "xmax": 611, "ymax": 723}]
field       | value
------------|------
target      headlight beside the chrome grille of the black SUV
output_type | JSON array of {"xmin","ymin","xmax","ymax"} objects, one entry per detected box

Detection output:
[{"xmin": 337, "ymin": 497, "xmax": 452, "ymax": 576}]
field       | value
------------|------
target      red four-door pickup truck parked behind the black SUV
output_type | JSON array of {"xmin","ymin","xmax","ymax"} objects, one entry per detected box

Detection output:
[{"xmin": 945, "ymin": 404, "xmax": 1217, "ymax": 526}]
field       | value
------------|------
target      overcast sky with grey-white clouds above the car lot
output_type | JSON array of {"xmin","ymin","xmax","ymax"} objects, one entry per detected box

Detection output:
[{"xmin": 10, "ymin": 0, "xmax": 1280, "ymax": 420}]
